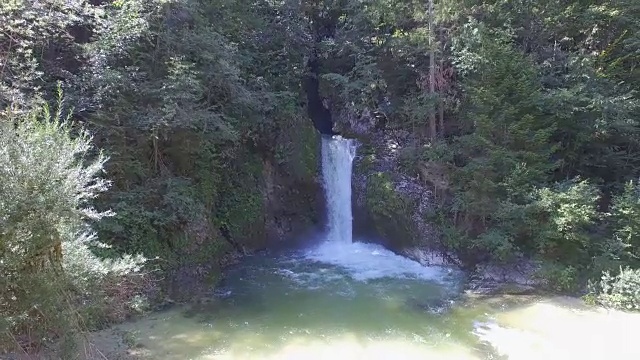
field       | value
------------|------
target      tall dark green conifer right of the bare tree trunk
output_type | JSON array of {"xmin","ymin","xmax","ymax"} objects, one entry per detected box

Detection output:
[{"xmin": 428, "ymin": 26, "xmax": 555, "ymax": 262}]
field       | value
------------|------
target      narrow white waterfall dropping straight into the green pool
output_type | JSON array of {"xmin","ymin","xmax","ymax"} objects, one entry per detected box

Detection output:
[{"xmin": 322, "ymin": 136, "xmax": 356, "ymax": 243}]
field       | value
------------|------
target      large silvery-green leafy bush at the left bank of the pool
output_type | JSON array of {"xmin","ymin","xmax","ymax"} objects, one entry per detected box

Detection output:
[{"xmin": 0, "ymin": 93, "xmax": 144, "ymax": 349}]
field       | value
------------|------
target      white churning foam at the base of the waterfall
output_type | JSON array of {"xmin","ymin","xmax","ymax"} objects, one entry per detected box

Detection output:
[{"xmin": 304, "ymin": 241, "xmax": 448, "ymax": 281}]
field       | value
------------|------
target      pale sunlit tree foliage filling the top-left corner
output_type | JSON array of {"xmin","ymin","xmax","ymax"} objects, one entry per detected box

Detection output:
[{"xmin": 0, "ymin": 0, "xmax": 97, "ymax": 111}]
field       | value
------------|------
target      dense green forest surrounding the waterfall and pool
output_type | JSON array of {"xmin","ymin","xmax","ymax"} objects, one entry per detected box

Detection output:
[{"xmin": 0, "ymin": 0, "xmax": 640, "ymax": 354}]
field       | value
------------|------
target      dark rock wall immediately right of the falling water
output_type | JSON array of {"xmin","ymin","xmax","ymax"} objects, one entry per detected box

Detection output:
[{"xmin": 338, "ymin": 109, "xmax": 448, "ymax": 264}]
